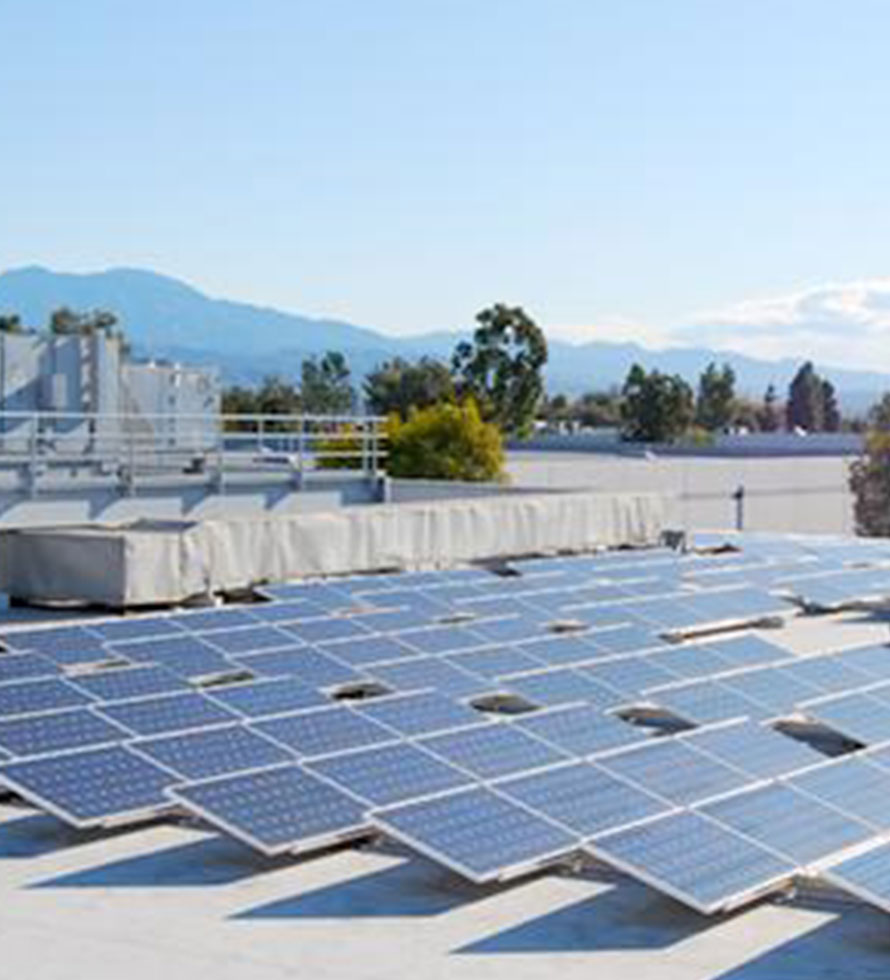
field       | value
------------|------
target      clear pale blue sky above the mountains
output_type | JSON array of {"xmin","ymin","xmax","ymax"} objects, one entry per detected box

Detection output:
[{"xmin": 0, "ymin": 0, "xmax": 890, "ymax": 362}]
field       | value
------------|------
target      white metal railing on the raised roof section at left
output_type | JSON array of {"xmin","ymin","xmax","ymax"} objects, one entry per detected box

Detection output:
[{"xmin": 0, "ymin": 411, "xmax": 386, "ymax": 494}]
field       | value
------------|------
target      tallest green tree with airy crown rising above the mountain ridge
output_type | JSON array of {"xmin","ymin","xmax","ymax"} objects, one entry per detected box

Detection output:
[{"xmin": 451, "ymin": 303, "xmax": 547, "ymax": 437}]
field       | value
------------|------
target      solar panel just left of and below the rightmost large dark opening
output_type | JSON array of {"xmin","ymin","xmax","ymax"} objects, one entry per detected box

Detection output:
[{"xmin": 684, "ymin": 721, "xmax": 824, "ymax": 779}]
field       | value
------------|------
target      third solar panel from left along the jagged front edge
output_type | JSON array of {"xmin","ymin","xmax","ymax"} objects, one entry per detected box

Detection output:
[{"xmin": 371, "ymin": 787, "xmax": 578, "ymax": 882}]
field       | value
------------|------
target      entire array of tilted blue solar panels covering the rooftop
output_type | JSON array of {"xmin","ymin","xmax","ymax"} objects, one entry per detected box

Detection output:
[{"xmin": 0, "ymin": 536, "xmax": 890, "ymax": 912}]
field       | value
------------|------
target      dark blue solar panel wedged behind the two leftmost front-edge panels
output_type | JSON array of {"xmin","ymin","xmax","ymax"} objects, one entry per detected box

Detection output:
[{"xmin": 132, "ymin": 725, "xmax": 293, "ymax": 780}]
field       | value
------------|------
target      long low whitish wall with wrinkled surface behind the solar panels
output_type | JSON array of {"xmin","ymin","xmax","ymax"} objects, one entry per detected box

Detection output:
[{"xmin": 0, "ymin": 492, "xmax": 668, "ymax": 608}]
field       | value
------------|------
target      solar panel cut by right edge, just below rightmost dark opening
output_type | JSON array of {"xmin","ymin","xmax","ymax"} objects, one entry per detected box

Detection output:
[{"xmin": 789, "ymin": 756, "xmax": 890, "ymax": 830}]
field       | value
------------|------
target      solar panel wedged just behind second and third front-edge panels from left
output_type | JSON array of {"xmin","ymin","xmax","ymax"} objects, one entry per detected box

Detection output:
[{"xmin": 307, "ymin": 742, "xmax": 470, "ymax": 806}]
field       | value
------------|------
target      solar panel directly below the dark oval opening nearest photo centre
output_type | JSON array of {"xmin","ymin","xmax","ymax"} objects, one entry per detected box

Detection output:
[{"xmin": 420, "ymin": 722, "xmax": 567, "ymax": 779}]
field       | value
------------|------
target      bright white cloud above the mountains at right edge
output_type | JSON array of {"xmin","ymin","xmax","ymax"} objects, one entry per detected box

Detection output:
[{"xmin": 673, "ymin": 278, "xmax": 890, "ymax": 371}]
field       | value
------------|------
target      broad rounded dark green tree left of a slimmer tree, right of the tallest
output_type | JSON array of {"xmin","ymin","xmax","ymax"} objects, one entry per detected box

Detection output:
[{"xmin": 621, "ymin": 364, "xmax": 695, "ymax": 442}]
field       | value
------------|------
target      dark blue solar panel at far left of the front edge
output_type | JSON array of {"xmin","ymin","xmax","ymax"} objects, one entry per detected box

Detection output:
[{"xmin": 0, "ymin": 746, "xmax": 174, "ymax": 827}]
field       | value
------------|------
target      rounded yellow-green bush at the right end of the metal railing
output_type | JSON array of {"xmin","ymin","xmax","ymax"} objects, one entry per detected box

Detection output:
[{"xmin": 386, "ymin": 399, "xmax": 504, "ymax": 482}]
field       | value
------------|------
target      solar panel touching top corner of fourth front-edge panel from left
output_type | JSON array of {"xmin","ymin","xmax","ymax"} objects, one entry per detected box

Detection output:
[{"xmin": 599, "ymin": 739, "xmax": 751, "ymax": 805}]
